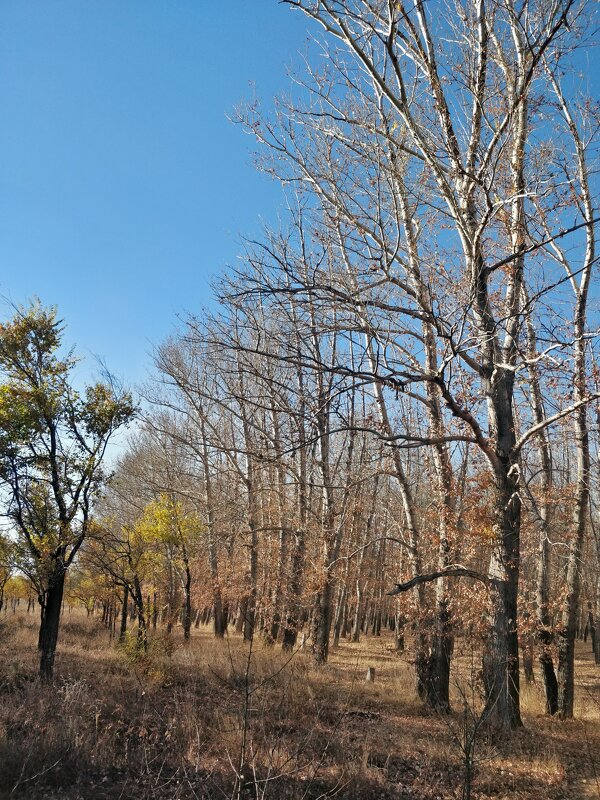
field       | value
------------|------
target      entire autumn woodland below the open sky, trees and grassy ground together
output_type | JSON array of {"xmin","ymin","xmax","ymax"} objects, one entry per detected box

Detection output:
[{"xmin": 0, "ymin": 0, "xmax": 600, "ymax": 800}]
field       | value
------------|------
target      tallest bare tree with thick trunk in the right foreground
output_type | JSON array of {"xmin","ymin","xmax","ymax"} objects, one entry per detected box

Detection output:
[{"xmin": 230, "ymin": 0, "xmax": 593, "ymax": 727}]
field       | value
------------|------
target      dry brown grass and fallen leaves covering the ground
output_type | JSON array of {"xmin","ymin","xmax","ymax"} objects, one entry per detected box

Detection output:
[{"xmin": 0, "ymin": 611, "xmax": 600, "ymax": 800}]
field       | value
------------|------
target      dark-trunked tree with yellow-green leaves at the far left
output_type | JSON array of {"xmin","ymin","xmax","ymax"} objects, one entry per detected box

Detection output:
[{"xmin": 0, "ymin": 302, "xmax": 135, "ymax": 680}]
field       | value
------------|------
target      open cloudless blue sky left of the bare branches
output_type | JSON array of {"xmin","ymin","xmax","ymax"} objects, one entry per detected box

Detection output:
[{"xmin": 0, "ymin": 0, "xmax": 307, "ymax": 383}]
